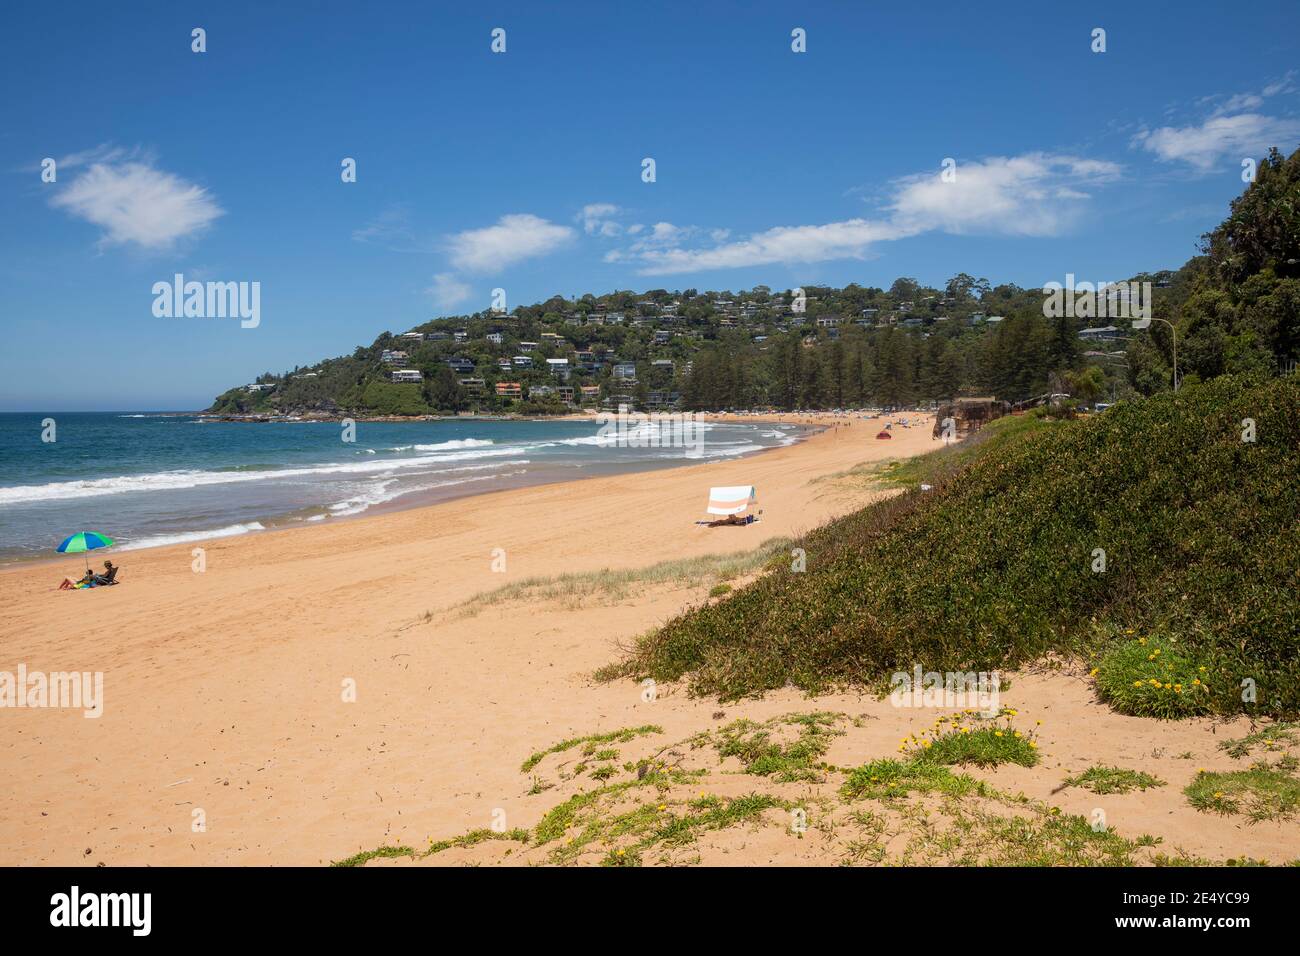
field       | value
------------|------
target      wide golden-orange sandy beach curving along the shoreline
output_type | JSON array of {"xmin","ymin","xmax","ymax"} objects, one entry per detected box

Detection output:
[{"xmin": 0, "ymin": 415, "xmax": 1300, "ymax": 866}]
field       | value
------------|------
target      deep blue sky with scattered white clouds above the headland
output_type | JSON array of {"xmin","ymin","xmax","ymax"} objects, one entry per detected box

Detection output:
[{"xmin": 0, "ymin": 1, "xmax": 1300, "ymax": 411}]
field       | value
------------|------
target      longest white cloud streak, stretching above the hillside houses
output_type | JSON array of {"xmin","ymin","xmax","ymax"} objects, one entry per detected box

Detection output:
[{"xmin": 605, "ymin": 152, "xmax": 1122, "ymax": 276}]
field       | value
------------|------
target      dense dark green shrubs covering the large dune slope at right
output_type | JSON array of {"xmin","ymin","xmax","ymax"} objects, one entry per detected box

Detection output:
[{"xmin": 599, "ymin": 376, "xmax": 1300, "ymax": 718}]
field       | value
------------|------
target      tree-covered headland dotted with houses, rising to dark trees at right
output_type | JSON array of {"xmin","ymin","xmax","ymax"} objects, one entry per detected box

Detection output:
[{"xmin": 212, "ymin": 150, "xmax": 1300, "ymax": 415}]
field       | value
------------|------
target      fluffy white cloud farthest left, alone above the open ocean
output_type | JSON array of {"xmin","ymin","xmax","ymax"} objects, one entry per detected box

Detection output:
[{"xmin": 51, "ymin": 160, "xmax": 224, "ymax": 250}]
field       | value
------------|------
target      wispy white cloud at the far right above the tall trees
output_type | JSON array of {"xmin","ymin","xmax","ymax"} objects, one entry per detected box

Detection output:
[{"xmin": 1132, "ymin": 72, "xmax": 1300, "ymax": 173}]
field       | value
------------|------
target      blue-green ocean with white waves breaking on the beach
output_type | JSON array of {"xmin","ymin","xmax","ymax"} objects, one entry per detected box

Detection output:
[{"xmin": 0, "ymin": 412, "xmax": 807, "ymax": 563}]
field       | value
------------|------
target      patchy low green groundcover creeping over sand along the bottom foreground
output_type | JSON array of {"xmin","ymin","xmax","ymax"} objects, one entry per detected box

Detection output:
[{"xmin": 334, "ymin": 708, "xmax": 1297, "ymax": 866}]
